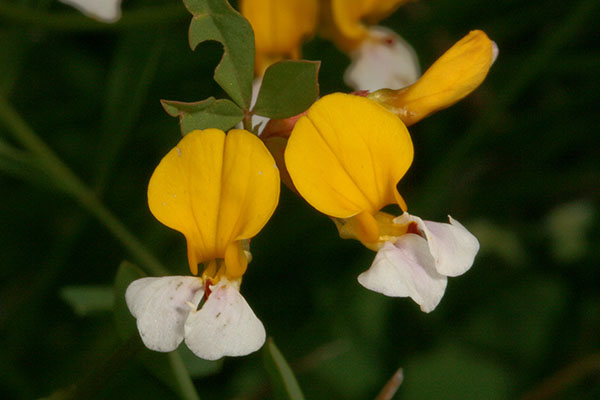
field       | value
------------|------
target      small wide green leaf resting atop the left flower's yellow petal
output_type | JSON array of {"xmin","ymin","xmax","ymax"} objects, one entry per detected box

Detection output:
[{"xmin": 160, "ymin": 97, "xmax": 244, "ymax": 136}]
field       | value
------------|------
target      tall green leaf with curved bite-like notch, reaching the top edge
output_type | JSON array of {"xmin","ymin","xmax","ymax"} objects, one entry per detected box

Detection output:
[{"xmin": 184, "ymin": 0, "xmax": 254, "ymax": 110}]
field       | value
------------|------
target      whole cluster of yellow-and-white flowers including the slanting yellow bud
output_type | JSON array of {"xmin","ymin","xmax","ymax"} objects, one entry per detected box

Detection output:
[{"xmin": 126, "ymin": 0, "xmax": 498, "ymax": 360}]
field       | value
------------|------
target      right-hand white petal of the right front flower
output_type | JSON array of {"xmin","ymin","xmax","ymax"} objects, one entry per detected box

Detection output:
[{"xmin": 394, "ymin": 213, "xmax": 479, "ymax": 276}]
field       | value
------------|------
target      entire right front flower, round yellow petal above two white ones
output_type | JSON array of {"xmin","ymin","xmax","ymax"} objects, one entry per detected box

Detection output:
[{"xmin": 285, "ymin": 93, "xmax": 479, "ymax": 312}]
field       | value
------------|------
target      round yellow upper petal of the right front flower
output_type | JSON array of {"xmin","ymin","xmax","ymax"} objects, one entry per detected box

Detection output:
[{"xmin": 285, "ymin": 93, "xmax": 413, "ymax": 218}]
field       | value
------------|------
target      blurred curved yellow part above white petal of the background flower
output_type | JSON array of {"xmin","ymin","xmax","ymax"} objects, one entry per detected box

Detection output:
[{"xmin": 321, "ymin": 0, "xmax": 410, "ymax": 51}]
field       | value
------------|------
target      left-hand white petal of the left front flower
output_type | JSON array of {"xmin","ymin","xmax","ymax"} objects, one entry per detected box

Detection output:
[{"xmin": 125, "ymin": 276, "xmax": 204, "ymax": 351}]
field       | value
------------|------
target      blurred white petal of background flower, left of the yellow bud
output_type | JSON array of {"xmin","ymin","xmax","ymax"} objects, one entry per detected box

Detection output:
[{"xmin": 344, "ymin": 26, "xmax": 420, "ymax": 91}]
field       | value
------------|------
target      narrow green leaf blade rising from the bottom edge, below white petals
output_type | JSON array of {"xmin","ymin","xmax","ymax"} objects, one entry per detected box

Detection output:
[{"xmin": 263, "ymin": 338, "xmax": 304, "ymax": 400}]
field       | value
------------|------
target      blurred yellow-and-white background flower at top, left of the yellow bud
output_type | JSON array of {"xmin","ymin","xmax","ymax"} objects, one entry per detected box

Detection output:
[{"xmin": 320, "ymin": 0, "xmax": 420, "ymax": 91}]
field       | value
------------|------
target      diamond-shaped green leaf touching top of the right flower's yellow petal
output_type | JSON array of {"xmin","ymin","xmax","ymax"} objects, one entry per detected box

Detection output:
[{"xmin": 253, "ymin": 61, "xmax": 321, "ymax": 118}]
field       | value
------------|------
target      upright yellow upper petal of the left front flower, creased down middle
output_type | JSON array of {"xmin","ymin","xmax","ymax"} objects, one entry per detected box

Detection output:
[{"xmin": 148, "ymin": 129, "xmax": 279, "ymax": 276}]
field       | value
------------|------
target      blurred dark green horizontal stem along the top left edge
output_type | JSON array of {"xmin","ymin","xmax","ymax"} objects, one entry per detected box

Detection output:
[{"xmin": 0, "ymin": 2, "xmax": 189, "ymax": 32}]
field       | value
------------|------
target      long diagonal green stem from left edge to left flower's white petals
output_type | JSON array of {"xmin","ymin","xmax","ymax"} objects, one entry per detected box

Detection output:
[{"xmin": 0, "ymin": 96, "xmax": 168, "ymax": 276}]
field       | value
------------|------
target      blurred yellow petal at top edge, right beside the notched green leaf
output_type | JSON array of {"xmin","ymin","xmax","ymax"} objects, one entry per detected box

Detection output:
[{"xmin": 240, "ymin": 0, "xmax": 318, "ymax": 76}]
